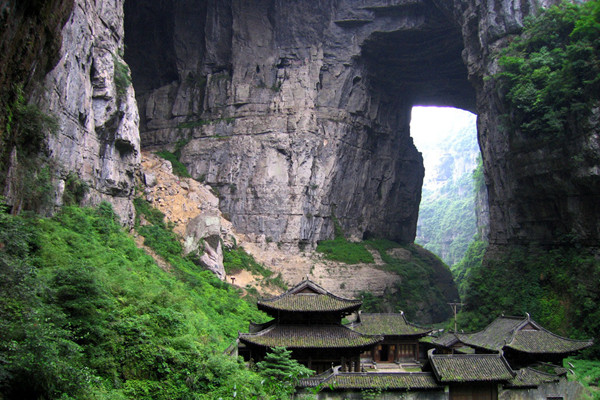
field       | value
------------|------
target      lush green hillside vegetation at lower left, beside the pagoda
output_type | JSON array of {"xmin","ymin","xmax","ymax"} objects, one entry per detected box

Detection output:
[{"xmin": 0, "ymin": 203, "xmax": 279, "ymax": 399}]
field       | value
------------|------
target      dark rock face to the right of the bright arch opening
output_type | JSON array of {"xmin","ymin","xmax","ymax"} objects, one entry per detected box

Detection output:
[{"xmin": 446, "ymin": 0, "xmax": 600, "ymax": 247}]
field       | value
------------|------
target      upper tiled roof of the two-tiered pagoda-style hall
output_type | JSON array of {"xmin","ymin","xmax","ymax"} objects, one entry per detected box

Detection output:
[{"xmin": 257, "ymin": 280, "xmax": 362, "ymax": 312}]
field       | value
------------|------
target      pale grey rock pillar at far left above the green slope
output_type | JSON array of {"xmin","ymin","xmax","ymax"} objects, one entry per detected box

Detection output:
[{"xmin": 2, "ymin": 0, "xmax": 140, "ymax": 223}]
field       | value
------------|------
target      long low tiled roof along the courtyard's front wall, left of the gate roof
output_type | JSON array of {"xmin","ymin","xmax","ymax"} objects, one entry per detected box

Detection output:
[{"xmin": 298, "ymin": 372, "xmax": 443, "ymax": 390}]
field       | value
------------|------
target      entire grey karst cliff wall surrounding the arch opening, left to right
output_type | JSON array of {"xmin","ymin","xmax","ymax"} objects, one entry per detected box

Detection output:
[{"xmin": 5, "ymin": 0, "xmax": 600, "ymax": 253}]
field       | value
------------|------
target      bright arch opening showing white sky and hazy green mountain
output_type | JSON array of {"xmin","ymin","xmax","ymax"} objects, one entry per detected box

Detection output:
[{"xmin": 410, "ymin": 107, "xmax": 479, "ymax": 265}]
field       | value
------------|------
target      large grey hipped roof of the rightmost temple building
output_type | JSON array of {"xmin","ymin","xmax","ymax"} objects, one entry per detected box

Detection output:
[{"xmin": 457, "ymin": 315, "xmax": 593, "ymax": 354}]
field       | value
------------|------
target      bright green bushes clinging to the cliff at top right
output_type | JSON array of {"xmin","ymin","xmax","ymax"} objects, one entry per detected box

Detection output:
[{"xmin": 495, "ymin": 0, "xmax": 600, "ymax": 140}]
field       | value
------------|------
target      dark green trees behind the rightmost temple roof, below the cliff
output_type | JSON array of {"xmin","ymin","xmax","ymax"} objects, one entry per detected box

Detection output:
[{"xmin": 460, "ymin": 246, "xmax": 600, "ymax": 357}]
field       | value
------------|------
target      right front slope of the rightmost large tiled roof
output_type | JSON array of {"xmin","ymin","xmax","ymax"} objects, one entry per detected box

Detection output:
[{"xmin": 507, "ymin": 329, "xmax": 593, "ymax": 354}]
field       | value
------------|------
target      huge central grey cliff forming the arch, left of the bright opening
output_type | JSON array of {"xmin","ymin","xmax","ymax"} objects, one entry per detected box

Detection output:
[{"xmin": 126, "ymin": 0, "xmax": 475, "ymax": 246}]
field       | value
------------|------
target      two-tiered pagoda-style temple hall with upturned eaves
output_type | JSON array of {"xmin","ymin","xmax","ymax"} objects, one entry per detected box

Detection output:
[{"xmin": 238, "ymin": 280, "xmax": 383, "ymax": 373}]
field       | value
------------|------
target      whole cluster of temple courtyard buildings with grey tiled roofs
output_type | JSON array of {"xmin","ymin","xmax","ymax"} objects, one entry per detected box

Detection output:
[{"xmin": 237, "ymin": 280, "xmax": 593, "ymax": 400}]
